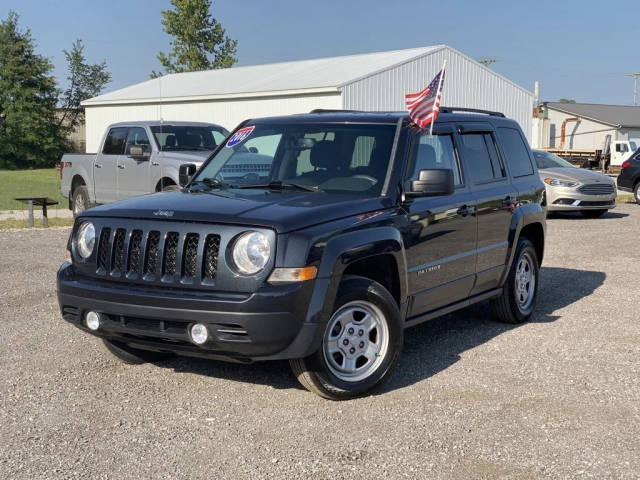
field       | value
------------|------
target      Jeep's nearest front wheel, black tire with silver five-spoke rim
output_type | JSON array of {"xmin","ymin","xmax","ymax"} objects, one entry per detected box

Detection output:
[{"xmin": 290, "ymin": 276, "xmax": 404, "ymax": 400}]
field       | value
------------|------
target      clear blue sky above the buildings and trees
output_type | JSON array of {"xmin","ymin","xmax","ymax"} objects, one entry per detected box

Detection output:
[{"xmin": 0, "ymin": 0, "xmax": 640, "ymax": 104}]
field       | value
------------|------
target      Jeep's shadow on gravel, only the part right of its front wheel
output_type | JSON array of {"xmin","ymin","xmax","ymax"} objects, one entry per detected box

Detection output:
[{"xmin": 380, "ymin": 267, "xmax": 606, "ymax": 393}]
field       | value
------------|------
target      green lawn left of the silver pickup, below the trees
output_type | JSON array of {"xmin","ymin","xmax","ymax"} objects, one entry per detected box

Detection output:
[{"xmin": 0, "ymin": 168, "xmax": 68, "ymax": 210}]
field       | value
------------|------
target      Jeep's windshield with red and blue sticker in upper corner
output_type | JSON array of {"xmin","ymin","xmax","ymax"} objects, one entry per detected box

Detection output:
[{"xmin": 194, "ymin": 123, "xmax": 396, "ymax": 196}]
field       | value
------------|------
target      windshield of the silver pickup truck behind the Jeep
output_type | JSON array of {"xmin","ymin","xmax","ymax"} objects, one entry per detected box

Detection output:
[{"xmin": 151, "ymin": 125, "xmax": 229, "ymax": 152}]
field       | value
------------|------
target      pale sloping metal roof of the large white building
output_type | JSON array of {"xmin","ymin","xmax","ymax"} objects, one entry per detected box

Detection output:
[{"xmin": 82, "ymin": 45, "xmax": 450, "ymax": 106}]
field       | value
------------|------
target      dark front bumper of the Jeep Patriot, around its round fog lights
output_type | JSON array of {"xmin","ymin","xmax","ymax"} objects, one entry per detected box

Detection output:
[{"xmin": 58, "ymin": 263, "xmax": 323, "ymax": 362}]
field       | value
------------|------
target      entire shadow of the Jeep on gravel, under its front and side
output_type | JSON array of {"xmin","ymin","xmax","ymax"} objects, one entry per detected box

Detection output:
[{"xmin": 156, "ymin": 267, "xmax": 605, "ymax": 393}]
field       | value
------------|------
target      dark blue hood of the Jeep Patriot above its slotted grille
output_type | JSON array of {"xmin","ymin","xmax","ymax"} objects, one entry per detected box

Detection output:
[{"xmin": 83, "ymin": 189, "xmax": 390, "ymax": 233}]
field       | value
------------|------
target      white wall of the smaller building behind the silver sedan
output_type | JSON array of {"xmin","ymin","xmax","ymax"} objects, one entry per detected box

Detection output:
[{"xmin": 542, "ymin": 109, "xmax": 616, "ymax": 150}]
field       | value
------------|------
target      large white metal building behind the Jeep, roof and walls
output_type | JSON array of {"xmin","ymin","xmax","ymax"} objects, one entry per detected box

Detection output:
[{"xmin": 82, "ymin": 45, "xmax": 533, "ymax": 152}]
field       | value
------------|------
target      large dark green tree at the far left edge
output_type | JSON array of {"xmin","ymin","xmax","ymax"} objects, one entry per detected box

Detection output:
[{"xmin": 0, "ymin": 11, "xmax": 64, "ymax": 168}]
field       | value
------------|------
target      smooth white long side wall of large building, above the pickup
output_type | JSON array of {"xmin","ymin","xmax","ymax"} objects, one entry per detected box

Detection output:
[{"xmin": 86, "ymin": 93, "xmax": 342, "ymax": 152}]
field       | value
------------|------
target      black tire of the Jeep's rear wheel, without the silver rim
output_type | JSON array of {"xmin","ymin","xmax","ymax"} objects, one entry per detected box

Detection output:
[{"xmin": 491, "ymin": 237, "xmax": 540, "ymax": 324}]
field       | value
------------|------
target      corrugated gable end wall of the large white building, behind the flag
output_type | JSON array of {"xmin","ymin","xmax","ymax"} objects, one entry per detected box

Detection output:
[{"xmin": 342, "ymin": 47, "xmax": 533, "ymax": 140}]
